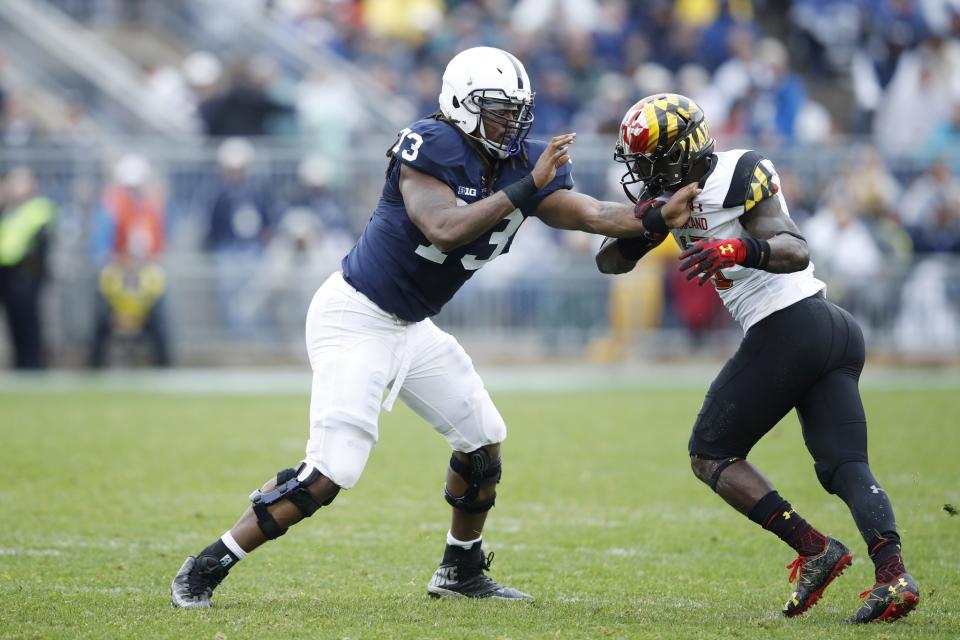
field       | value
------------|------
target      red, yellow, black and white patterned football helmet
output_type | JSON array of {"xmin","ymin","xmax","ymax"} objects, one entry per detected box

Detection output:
[{"xmin": 613, "ymin": 93, "xmax": 716, "ymax": 202}]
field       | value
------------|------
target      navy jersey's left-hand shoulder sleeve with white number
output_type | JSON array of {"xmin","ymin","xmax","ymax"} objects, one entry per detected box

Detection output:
[{"xmin": 393, "ymin": 120, "xmax": 466, "ymax": 183}]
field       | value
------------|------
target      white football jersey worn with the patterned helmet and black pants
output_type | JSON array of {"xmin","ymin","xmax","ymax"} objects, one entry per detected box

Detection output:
[{"xmin": 658, "ymin": 149, "xmax": 826, "ymax": 332}]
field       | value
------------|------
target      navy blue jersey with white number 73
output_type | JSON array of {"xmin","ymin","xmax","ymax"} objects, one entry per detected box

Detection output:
[{"xmin": 342, "ymin": 119, "xmax": 573, "ymax": 322}]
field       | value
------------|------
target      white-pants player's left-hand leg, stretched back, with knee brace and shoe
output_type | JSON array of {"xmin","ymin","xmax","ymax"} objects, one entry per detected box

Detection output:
[{"xmin": 172, "ymin": 277, "xmax": 402, "ymax": 608}]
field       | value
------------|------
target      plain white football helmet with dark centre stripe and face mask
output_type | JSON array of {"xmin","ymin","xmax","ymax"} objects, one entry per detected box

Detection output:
[{"xmin": 440, "ymin": 47, "xmax": 534, "ymax": 159}]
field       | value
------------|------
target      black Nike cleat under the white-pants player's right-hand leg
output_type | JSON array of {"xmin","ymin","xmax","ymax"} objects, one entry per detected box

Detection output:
[{"xmin": 427, "ymin": 546, "xmax": 533, "ymax": 600}]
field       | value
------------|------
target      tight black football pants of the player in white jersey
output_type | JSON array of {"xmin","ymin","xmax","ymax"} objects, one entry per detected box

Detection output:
[{"xmin": 689, "ymin": 293, "xmax": 867, "ymax": 492}]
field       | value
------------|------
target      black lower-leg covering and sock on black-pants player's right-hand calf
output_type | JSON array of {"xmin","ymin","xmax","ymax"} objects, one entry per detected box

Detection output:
[{"xmin": 830, "ymin": 462, "xmax": 904, "ymax": 582}]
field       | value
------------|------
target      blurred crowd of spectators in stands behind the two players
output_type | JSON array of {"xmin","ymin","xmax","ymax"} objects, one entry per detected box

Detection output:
[{"xmin": 0, "ymin": 0, "xmax": 960, "ymax": 366}]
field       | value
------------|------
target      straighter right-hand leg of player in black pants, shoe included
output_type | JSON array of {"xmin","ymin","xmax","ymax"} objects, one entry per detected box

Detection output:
[{"xmin": 797, "ymin": 303, "xmax": 920, "ymax": 622}]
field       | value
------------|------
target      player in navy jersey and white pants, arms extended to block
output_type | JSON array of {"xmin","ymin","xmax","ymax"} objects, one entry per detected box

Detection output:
[{"xmin": 172, "ymin": 47, "xmax": 692, "ymax": 608}]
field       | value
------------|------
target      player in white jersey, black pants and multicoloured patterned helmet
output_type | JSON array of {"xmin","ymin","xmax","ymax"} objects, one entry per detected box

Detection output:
[{"xmin": 597, "ymin": 93, "xmax": 920, "ymax": 622}]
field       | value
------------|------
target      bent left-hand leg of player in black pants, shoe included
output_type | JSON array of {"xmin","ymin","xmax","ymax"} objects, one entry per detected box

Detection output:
[{"xmin": 689, "ymin": 294, "xmax": 850, "ymax": 616}]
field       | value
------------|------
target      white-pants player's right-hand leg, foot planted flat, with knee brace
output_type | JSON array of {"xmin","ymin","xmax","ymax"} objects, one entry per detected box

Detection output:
[{"xmin": 400, "ymin": 320, "xmax": 530, "ymax": 600}]
